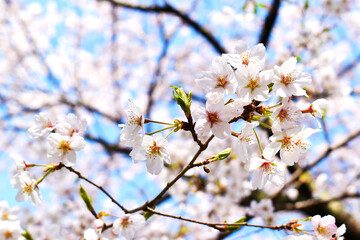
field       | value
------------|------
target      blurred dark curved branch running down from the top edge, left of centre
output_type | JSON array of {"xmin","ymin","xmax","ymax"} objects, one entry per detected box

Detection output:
[{"xmin": 99, "ymin": 0, "xmax": 226, "ymax": 54}]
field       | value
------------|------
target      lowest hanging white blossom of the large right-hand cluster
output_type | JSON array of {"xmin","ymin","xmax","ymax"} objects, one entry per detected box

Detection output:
[{"xmin": 249, "ymin": 152, "xmax": 285, "ymax": 189}]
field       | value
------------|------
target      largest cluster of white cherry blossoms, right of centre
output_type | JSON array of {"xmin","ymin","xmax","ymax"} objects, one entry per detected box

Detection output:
[{"xmin": 193, "ymin": 41, "xmax": 326, "ymax": 189}]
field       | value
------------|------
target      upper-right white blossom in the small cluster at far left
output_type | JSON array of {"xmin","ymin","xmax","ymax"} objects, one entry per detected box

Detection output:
[{"xmin": 56, "ymin": 113, "xmax": 87, "ymax": 137}]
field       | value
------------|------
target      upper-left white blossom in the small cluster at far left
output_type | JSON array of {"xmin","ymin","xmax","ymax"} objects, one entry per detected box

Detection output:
[{"xmin": 28, "ymin": 112, "xmax": 55, "ymax": 138}]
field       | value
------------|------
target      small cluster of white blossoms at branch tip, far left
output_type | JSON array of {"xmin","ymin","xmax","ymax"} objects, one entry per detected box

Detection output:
[{"xmin": 11, "ymin": 112, "xmax": 87, "ymax": 205}]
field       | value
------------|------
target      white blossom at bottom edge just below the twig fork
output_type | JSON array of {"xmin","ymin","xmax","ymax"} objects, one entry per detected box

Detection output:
[{"xmin": 113, "ymin": 213, "xmax": 145, "ymax": 240}]
